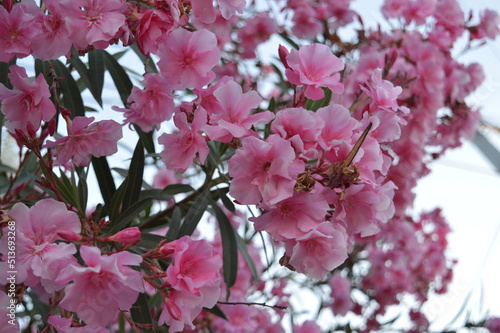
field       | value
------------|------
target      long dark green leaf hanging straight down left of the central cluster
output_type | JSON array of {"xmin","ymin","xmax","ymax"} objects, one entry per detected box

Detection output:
[{"xmin": 210, "ymin": 199, "xmax": 238, "ymax": 292}]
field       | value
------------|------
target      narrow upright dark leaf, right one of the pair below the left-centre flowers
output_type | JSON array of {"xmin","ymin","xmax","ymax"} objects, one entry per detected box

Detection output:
[{"xmin": 122, "ymin": 139, "xmax": 144, "ymax": 211}]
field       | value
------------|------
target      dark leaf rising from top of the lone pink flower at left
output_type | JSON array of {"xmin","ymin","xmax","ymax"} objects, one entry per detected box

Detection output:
[{"xmin": 50, "ymin": 60, "xmax": 85, "ymax": 117}]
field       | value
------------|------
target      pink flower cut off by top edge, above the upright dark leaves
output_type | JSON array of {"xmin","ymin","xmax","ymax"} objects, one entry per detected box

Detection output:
[{"xmin": 59, "ymin": 0, "xmax": 127, "ymax": 50}]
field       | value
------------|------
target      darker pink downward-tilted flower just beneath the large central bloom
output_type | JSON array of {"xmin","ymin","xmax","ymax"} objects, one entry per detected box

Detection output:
[{"xmin": 249, "ymin": 192, "xmax": 330, "ymax": 240}]
